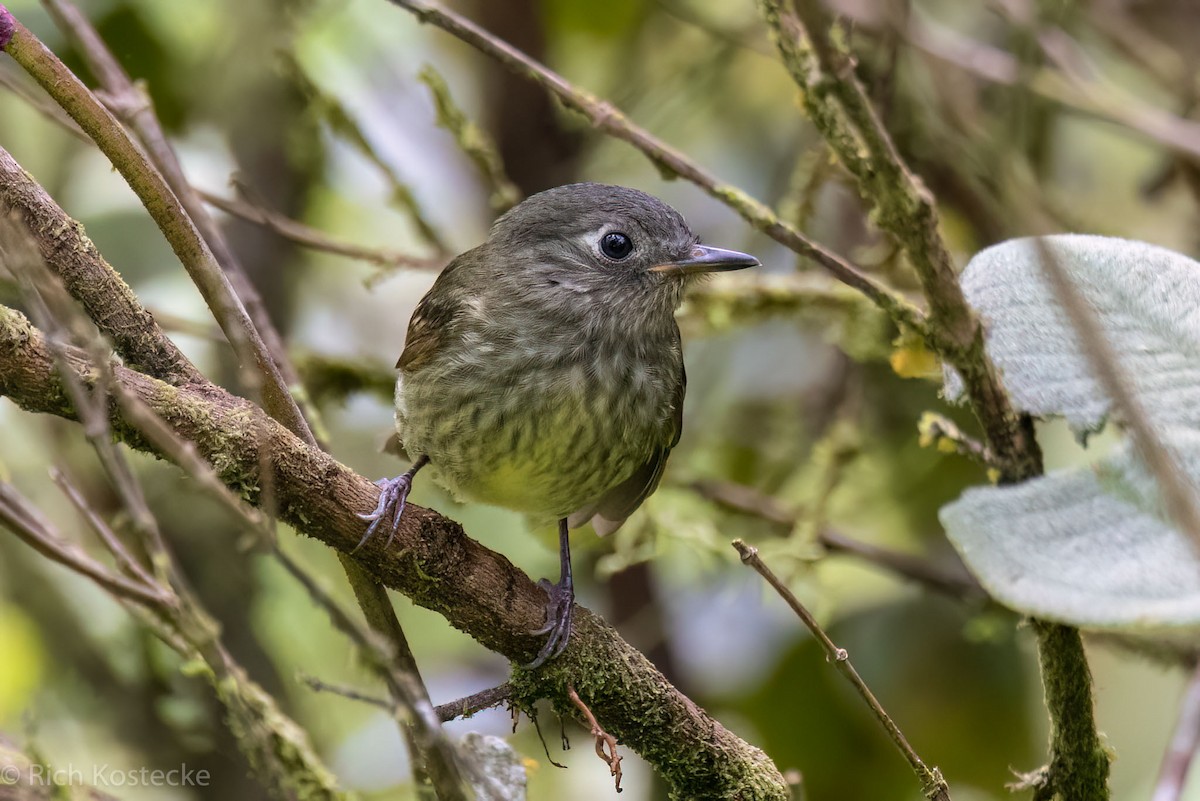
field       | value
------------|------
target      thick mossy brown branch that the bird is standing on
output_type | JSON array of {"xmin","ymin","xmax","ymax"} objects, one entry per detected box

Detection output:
[{"xmin": 0, "ymin": 307, "xmax": 787, "ymax": 800}]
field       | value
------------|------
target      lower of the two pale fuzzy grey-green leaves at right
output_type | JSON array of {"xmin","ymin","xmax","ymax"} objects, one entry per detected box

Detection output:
[{"xmin": 940, "ymin": 428, "xmax": 1200, "ymax": 633}]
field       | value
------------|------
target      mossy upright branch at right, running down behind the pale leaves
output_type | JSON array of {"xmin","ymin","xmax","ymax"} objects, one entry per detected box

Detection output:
[{"xmin": 758, "ymin": 0, "xmax": 1109, "ymax": 801}]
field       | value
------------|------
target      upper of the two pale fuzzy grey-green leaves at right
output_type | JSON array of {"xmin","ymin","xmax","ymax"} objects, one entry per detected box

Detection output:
[{"xmin": 946, "ymin": 235, "xmax": 1200, "ymax": 433}]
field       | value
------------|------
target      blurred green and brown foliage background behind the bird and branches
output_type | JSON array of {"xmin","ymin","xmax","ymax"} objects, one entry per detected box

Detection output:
[{"xmin": 0, "ymin": 0, "xmax": 1200, "ymax": 801}]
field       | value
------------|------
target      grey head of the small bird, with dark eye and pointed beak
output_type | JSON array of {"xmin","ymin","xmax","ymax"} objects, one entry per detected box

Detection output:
[{"xmin": 487, "ymin": 183, "xmax": 758, "ymax": 308}]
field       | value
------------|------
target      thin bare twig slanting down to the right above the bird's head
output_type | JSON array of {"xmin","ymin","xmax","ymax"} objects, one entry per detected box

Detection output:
[{"xmin": 388, "ymin": 0, "xmax": 924, "ymax": 331}]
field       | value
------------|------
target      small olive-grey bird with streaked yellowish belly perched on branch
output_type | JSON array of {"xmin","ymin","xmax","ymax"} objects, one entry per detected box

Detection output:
[{"xmin": 359, "ymin": 183, "xmax": 758, "ymax": 668}]
